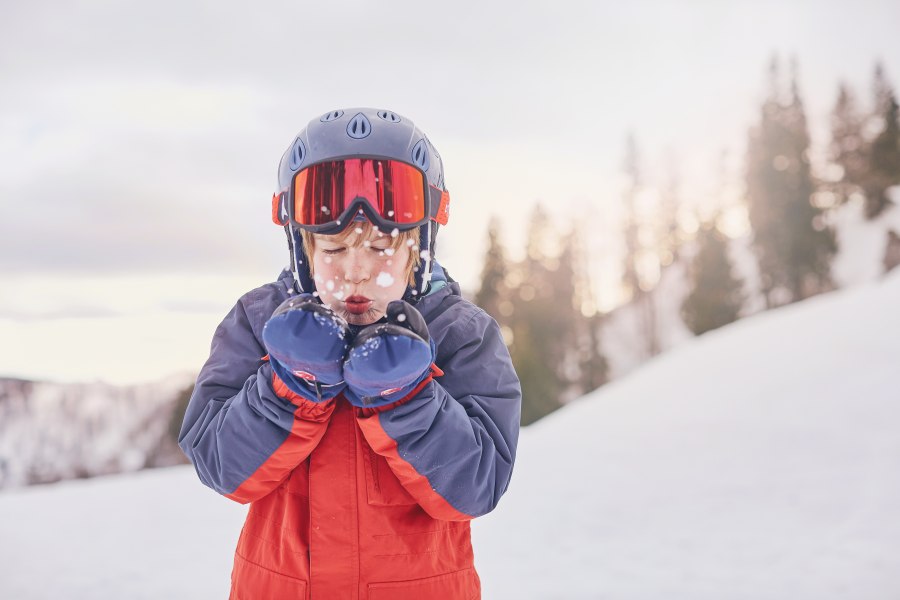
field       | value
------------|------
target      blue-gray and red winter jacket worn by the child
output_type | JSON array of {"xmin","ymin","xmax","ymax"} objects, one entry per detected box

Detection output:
[{"xmin": 179, "ymin": 268, "xmax": 521, "ymax": 600}]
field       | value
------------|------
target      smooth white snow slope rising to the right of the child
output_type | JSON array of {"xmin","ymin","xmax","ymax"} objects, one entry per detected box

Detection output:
[{"xmin": 475, "ymin": 273, "xmax": 900, "ymax": 600}]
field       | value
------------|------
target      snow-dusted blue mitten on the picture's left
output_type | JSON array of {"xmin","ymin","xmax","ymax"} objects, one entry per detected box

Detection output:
[{"xmin": 263, "ymin": 294, "xmax": 349, "ymax": 402}]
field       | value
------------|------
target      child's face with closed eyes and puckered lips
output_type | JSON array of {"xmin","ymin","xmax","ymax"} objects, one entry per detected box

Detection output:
[{"xmin": 312, "ymin": 225, "xmax": 410, "ymax": 325}]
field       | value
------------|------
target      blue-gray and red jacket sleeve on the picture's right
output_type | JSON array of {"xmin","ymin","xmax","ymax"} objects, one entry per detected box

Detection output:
[{"xmin": 357, "ymin": 309, "xmax": 522, "ymax": 521}]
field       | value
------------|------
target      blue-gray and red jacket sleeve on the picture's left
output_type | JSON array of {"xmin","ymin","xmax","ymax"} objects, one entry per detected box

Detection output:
[{"xmin": 178, "ymin": 292, "xmax": 334, "ymax": 504}]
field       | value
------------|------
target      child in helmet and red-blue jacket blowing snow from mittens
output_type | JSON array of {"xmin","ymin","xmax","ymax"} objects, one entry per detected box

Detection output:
[{"xmin": 179, "ymin": 108, "xmax": 521, "ymax": 600}]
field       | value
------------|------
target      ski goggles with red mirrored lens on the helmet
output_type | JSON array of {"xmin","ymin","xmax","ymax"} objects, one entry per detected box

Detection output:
[{"xmin": 272, "ymin": 158, "xmax": 450, "ymax": 233}]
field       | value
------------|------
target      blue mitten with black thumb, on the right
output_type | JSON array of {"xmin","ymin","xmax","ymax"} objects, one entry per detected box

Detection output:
[{"xmin": 344, "ymin": 300, "xmax": 435, "ymax": 408}]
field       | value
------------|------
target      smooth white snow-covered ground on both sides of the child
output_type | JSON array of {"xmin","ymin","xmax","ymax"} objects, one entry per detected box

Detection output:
[{"xmin": 0, "ymin": 273, "xmax": 900, "ymax": 600}]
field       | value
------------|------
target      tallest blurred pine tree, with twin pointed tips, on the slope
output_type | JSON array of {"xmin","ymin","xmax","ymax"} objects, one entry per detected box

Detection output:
[{"xmin": 747, "ymin": 61, "xmax": 836, "ymax": 307}]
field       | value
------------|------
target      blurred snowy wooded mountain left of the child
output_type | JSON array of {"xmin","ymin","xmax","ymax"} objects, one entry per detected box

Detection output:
[{"xmin": 0, "ymin": 375, "xmax": 192, "ymax": 489}]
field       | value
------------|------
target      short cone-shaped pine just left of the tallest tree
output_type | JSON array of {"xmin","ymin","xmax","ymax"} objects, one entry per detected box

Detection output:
[{"xmin": 681, "ymin": 222, "xmax": 743, "ymax": 335}]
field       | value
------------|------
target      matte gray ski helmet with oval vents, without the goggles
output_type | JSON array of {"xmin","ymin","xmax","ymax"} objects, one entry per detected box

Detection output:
[{"xmin": 276, "ymin": 108, "xmax": 447, "ymax": 302}]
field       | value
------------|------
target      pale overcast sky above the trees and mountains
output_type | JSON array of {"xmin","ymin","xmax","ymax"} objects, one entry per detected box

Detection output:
[{"xmin": 0, "ymin": 0, "xmax": 900, "ymax": 381}]
